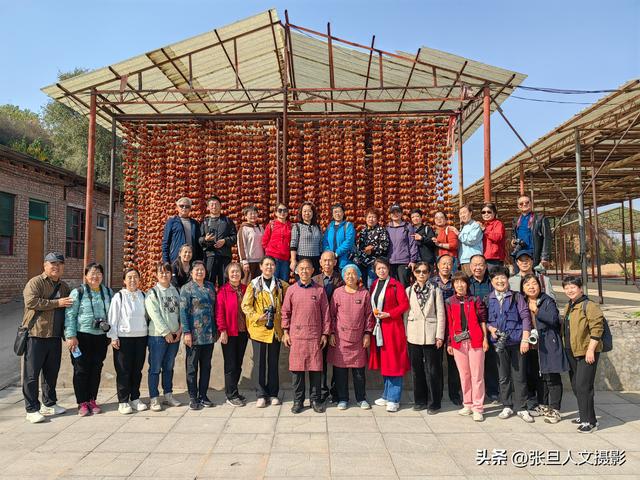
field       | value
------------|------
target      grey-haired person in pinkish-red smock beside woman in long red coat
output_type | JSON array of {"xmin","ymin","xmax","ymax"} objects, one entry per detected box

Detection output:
[{"xmin": 327, "ymin": 264, "xmax": 375, "ymax": 410}]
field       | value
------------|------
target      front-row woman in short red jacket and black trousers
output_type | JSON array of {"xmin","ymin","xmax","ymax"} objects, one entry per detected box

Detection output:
[{"xmin": 216, "ymin": 262, "xmax": 249, "ymax": 407}]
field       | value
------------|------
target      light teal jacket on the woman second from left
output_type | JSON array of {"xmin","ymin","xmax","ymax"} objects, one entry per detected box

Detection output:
[{"xmin": 64, "ymin": 284, "xmax": 113, "ymax": 338}]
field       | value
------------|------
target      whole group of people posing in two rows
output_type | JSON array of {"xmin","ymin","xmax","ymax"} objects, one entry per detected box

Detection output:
[{"xmin": 18, "ymin": 192, "xmax": 603, "ymax": 432}]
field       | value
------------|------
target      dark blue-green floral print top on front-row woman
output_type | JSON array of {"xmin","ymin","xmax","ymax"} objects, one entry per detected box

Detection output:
[{"xmin": 180, "ymin": 281, "xmax": 217, "ymax": 345}]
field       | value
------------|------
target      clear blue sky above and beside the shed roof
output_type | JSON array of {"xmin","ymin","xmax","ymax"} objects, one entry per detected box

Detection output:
[{"xmin": 0, "ymin": 0, "xmax": 640, "ymax": 191}]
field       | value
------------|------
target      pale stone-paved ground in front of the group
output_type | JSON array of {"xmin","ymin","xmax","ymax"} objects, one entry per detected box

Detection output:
[{"xmin": 0, "ymin": 388, "xmax": 640, "ymax": 479}]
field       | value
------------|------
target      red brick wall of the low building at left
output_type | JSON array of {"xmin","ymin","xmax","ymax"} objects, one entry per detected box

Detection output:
[{"xmin": 0, "ymin": 149, "xmax": 124, "ymax": 303}]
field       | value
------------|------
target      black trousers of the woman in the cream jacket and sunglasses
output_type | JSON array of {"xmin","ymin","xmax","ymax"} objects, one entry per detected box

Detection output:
[{"xmin": 408, "ymin": 343, "xmax": 443, "ymax": 410}]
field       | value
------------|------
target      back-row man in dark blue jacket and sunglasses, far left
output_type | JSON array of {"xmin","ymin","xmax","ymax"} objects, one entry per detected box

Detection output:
[{"xmin": 162, "ymin": 197, "xmax": 201, "ymax": 263}]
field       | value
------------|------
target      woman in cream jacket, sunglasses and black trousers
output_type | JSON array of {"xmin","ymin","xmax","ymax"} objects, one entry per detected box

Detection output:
[{"xmin": 405, "ymin": 262, "xmax": 446, "ymax": 414}]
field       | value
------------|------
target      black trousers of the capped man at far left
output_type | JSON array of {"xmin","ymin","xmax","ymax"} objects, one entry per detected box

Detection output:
[{"xmin": 22, "ymin": 337, "xmax": 62, "ymax": 413}]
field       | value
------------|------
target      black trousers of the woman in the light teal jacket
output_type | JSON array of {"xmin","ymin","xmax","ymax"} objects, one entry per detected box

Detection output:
[{"xmin": 71, "ymin": 332, "xmax": 110, "ymax": 404}]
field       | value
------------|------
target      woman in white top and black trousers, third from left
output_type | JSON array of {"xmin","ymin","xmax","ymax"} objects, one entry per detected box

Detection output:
[{"xmin": 107, "ymin": 267, "xmax": 147, "ymax": 415}]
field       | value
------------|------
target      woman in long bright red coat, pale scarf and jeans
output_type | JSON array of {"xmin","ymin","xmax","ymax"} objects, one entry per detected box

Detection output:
[{"xmin": 369, "ymin": 258, "xmax": 410, "ymax": 412}]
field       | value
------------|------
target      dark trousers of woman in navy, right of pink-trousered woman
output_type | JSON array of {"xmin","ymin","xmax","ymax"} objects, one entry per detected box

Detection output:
[{"xmin": 498, "ymin": 344, "xmax": 527, "ymax": 411}]
